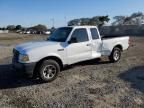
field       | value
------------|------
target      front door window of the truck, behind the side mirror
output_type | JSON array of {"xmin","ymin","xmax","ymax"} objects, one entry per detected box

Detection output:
[{"xmin": 71, "ymin": 28, "xmax": 89, "ymax": 43}]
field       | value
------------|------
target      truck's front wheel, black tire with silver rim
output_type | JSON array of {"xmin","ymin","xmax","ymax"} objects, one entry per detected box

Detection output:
[{"xmin": 39, "ymin": 60, "xmax": 60, "ymax": 82}]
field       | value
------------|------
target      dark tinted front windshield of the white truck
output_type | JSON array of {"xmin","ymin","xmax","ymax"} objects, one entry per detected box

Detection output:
[{"xmin": 47, "ymin": 27, "xmax": 72, "ymax": 42}]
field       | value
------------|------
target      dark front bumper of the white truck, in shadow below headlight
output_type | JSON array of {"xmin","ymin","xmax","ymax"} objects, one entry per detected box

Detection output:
[{"xmin": 12, "ymin": 63, "xmax": 36, "ymax": 77}]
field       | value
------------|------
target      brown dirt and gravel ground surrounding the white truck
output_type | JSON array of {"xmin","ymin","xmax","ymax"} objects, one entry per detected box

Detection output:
[{"xmin": 0, "ymin": 34, "xmax": 144, "ymax": 108}]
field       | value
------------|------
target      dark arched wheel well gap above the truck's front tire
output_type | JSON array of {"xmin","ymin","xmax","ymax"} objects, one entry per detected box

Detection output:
[{"xmin": 34, "ymin": 56, "xmax": 63, "ymax": 73}]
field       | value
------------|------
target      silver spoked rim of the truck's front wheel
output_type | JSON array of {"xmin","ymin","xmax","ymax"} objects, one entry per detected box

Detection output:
[{"xmin": 43, "ymin": 65, "xmax": 56, "ymax": 79}]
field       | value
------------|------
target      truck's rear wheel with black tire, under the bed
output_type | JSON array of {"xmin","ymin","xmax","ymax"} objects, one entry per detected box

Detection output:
[{"xmin": 109, "ymin": 47, "xmax": 121, "ymax": 63}]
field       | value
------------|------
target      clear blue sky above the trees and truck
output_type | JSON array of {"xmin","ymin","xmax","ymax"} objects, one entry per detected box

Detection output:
[{"xmin": 0, "ymin": 0, "xmax": 144, "ymax": 27}]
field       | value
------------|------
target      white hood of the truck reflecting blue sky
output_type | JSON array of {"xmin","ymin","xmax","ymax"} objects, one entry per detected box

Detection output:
[{"xmin": 15, "ymin": 41, "xmax": 59, "ymax": 53}]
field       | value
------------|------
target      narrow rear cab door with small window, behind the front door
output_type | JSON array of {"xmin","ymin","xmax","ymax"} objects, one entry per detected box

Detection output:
[{"xmin": 90, "ymin": 28, "xmax": 102, "ymax": 58}]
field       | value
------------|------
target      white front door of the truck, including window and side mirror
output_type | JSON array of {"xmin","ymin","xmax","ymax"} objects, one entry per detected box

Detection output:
[{"xmin": 67, "ymin": 28, "xmax": 91, "ymax": 64}]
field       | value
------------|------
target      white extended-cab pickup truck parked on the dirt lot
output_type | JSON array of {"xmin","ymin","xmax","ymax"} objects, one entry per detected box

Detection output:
[{"xmin": 12, "ymin": 26, "xmax": 129, "ymax": 82}]
